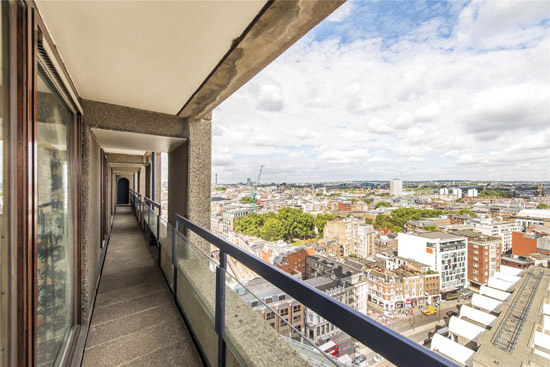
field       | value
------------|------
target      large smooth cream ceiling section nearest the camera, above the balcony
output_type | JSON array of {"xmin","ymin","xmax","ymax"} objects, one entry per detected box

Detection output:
[{"xmin": 36, "ymin": 0, "xmax": 266, "ymax": 114}]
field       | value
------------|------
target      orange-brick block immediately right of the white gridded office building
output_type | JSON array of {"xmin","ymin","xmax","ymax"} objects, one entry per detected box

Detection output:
[{"xmin": 453, "ymin": 230, "xmax": 502, "ymax": 288}]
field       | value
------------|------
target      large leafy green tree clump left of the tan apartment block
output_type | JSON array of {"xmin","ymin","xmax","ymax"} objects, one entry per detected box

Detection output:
[{"xmin": 234, "ymin": 208, "xmax": 334, "ymax": 241}]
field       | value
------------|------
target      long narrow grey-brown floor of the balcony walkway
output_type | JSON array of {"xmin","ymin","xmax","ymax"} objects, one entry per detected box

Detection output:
[{"xmin": 82, "ymin": 206, "xmax": 202, "ymax": 367}]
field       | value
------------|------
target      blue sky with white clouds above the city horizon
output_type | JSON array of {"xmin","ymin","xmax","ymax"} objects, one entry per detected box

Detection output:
[{"xmin": 212, "ymin": 0, "xmax": 550, "ymax": 183}]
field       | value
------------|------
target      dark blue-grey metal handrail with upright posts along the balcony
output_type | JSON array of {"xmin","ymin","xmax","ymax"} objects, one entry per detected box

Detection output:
[{"xmin": 129, "ymin": 193, "xmax": 458, "ymax": 366}]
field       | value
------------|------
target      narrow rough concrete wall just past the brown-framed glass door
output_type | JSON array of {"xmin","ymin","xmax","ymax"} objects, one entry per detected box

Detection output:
[{"xmin": 80, "ymin": 126, "xmax": 102, "ymax": 325}]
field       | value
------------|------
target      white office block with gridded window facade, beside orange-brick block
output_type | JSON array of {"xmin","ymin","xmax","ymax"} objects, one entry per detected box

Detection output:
[{"xmin": 397, "ymin": 232, "xmax": 467, "ymax": 290}]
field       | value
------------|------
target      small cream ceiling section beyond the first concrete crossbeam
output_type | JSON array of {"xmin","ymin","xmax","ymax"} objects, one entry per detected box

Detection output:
[{"xmin": 92, "ymin": 128, "xmax": 187, "ymax": 155}]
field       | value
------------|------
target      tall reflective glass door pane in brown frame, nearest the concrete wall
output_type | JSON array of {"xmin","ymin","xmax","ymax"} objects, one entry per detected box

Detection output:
[{"xmin": 36, "ymin": 68, "xmax": 76, "ymax": 366}]
